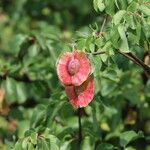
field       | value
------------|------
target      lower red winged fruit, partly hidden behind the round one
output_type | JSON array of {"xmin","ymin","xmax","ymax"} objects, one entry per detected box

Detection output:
[{"xmin": 65, "ymin": 76, "xmax": 94, "ymax": 108}]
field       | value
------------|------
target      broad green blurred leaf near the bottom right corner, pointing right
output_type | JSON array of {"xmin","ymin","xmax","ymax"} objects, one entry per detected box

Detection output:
[{"xmin": 120, "ymin": 131, "xmax": 144, "ymax": 147}]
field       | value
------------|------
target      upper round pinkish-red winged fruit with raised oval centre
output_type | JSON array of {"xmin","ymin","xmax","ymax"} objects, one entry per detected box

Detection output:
[{"xmin": 56, "ymin": 50, "xmax": 91, "ymax": 86}]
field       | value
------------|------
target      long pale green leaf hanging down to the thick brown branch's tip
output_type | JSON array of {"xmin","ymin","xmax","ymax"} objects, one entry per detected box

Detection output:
[{"xmin": 118, "ymin": 25, "xmax": 129, "ymax": 52}]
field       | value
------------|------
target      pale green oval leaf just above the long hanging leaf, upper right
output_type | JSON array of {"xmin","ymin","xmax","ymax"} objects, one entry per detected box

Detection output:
[{"xmin": 113, "ymin": 10, "xmax": 126, "ymax": 25}]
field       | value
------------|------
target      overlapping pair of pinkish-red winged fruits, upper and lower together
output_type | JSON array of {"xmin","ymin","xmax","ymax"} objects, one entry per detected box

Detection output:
[{"xmin": 56, "ymin": 50, "xmax": 94, "ymax": 108}]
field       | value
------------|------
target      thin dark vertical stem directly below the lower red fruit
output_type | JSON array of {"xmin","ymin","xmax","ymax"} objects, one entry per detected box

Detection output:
[{"xmin": 78, "ymin": 108, "xmax": 82, "ymax": 150}]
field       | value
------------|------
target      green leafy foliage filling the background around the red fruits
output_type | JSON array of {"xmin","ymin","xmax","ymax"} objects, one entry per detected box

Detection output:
[{"xmin": 0, "ymin": 0, "xmax": 150, "ymax": 150}]
